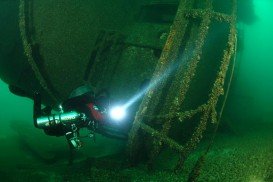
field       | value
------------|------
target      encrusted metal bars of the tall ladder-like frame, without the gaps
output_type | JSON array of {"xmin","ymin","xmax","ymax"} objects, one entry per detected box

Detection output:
[{"xmin": 129, "ymin": 0, "xmax": 237, "ymax": 169}]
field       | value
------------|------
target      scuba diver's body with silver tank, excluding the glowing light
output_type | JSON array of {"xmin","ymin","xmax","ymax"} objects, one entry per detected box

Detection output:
[{"xmin": 33, "ymin": 85, "xmax": 128, "ymax": 150}]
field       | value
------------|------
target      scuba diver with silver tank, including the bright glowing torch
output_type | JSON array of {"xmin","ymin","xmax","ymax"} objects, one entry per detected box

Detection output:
[{"xmin": 9, "ymin": 80, "xmax": 147, "ymax": 164}]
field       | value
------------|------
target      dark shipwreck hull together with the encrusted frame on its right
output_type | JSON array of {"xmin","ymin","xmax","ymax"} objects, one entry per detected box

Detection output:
[{"xmin": 0, "ymin": 0, "xmax": 237, "ymax": 174}]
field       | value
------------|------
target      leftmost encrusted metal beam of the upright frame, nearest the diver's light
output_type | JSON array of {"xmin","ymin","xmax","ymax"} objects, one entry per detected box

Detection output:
[{"xmin": 128, "ymin": 0, "xmax": 193, "ymax": 158}]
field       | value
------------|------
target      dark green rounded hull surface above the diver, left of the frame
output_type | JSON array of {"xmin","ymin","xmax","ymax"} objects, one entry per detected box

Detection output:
[{"xmin": 19, "ymin": 0, "xmax": 176, "ymax": 105}]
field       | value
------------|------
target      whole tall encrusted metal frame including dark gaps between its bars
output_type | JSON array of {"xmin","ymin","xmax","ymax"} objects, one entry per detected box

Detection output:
[{"xmin": 129, "ymin": 0, "xmax": 237, "ymax": 169}]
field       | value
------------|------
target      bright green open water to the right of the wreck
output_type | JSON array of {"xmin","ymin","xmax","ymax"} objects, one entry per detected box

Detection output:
[{"xmin": 226, "ymin": 0, "xmax": 273, "ymax": 130}]
